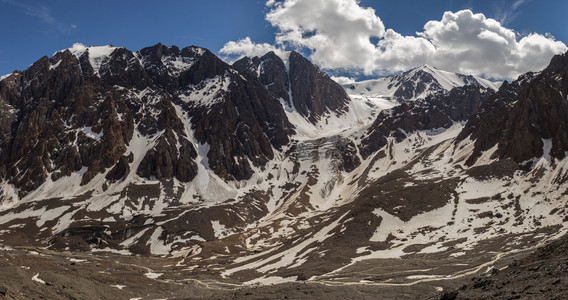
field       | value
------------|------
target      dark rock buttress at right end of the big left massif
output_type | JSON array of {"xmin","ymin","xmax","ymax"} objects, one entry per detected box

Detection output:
[{"xmin": 178, "ymin": 50, "xmax": 293, "ymax": 180}]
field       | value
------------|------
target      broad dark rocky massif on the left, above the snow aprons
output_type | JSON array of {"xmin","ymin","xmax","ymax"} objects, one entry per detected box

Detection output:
[{"xmin": 0, "ymin": 44, "xmax": 293, "ymax": 196}]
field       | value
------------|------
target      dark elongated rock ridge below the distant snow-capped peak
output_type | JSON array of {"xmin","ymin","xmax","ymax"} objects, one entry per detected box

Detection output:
[{"xmin": 360, "ymin": 85, "xmax": 493, "ymax": 158}]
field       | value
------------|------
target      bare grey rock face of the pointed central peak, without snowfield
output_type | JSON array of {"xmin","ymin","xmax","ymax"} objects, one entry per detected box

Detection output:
[{"xmin": 233, "ymin": 51, "xmax": 349, "ymax": 123}]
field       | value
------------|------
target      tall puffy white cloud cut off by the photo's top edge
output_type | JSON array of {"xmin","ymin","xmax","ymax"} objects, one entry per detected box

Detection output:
[{"xmin": 266, "ymin": 0, "xmax": 385, "ymax": 73}]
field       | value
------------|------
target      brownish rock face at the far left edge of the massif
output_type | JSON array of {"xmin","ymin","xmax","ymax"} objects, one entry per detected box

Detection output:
[{"xmin": 0, "ymin": 51, "xmax": 133, "ymax": 194}]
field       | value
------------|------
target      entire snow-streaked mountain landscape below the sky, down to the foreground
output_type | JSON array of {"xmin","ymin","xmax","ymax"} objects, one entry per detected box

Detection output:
[{"xmin": 0, "ymin": 44, "xmax": 568, "ymax": 299}]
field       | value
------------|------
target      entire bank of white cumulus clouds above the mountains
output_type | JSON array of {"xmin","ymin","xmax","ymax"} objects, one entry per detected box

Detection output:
[{"xmin": 221, "ymin": 0, "xmax": 568, "ymax": 79}]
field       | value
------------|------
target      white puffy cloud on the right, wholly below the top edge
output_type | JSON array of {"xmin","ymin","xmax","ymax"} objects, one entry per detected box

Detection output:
[{"xmin": 418, "ymin": 10, "xmax": 568, "ymax": 78}]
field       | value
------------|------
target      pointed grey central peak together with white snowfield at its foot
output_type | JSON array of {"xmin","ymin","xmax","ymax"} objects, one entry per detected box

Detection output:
[{"xmin": 233, "ymin": 51, "xmax": 374, "ymax": 138}]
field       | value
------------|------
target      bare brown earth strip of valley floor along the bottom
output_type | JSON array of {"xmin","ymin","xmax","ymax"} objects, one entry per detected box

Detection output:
[{"xmin": 0, "ymin": 228, "xmax": 568, "ymax": 299}]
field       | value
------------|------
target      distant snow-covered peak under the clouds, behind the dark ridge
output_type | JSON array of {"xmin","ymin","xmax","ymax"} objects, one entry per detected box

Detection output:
[{"xmin": 344, "ymin": 65, "xmax": 497, "ymax": 102}]
